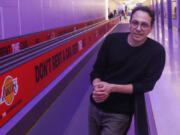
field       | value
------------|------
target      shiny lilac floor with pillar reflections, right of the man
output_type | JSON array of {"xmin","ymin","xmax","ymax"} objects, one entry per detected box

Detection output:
[{"xmin": 150, "ymin": 22, "xmax": 180, "ymax": 135}]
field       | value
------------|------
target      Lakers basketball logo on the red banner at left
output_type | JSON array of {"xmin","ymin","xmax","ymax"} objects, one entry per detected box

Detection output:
[{"xmin": 0, "ymin": 76, "xmax": 18, "ymax": 105}]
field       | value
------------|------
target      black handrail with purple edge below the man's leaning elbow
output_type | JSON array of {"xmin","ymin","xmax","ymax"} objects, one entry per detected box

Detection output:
[{"xmin": 134, "ymin": 93, "xmax": 158, "ymax": 135}]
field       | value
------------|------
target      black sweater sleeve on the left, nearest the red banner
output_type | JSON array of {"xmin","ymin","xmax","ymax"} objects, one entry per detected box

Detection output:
[{"xmin": 90, "ymin": 36, "xmax": 110, "ymax": 82}]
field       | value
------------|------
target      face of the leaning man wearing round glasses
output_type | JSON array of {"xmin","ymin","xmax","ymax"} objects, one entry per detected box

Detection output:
[{"xmin": 129, "ymin": 10, "xmax": 152, "ymax": 43}]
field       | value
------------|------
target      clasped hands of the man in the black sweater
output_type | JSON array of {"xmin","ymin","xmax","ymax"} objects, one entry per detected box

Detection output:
[{"xmin": 93, "ymin": 81, "xmax": 112, "ymax": 103}]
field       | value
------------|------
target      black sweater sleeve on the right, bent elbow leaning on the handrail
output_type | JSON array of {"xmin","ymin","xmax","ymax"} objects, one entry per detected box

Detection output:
[{"xmin": 133, "ymin": 47, "xmax": 165, "ymax": 93}]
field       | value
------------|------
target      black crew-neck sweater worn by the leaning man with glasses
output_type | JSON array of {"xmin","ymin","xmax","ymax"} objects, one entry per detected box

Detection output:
[{"xmin": 91, "ymin": 33, "xmax": 165, "ymax": 114}]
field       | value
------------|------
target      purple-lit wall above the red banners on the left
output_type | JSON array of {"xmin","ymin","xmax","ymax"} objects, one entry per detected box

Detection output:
[{"xmin": 0, "ymin": 0, "xmax": 105, "ymax": 40}]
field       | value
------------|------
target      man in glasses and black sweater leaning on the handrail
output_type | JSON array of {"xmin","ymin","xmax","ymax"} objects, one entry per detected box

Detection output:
[{"xmin": 88, "ymin": 7, "xmax": 165, "ymax": 135}]
